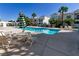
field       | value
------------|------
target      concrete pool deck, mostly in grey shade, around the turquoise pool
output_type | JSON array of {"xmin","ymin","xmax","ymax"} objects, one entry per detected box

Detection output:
[{"xmin": 0, "ymin": 28, "xmax": 79, "ymax": 56}]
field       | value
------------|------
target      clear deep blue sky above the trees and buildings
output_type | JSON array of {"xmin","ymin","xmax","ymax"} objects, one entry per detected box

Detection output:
[{"xmin": 0, "ymin": 3, "xmax": 79, "ymax": 21}]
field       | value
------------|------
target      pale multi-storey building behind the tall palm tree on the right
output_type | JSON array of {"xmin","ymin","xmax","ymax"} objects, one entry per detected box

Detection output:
[{"xmin": 51, "ymin": 9, "xmax": 79, "ymax": 27}]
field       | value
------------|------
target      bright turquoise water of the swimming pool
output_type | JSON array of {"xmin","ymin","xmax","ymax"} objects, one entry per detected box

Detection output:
[{"xmin": 22, "ymin": 27, "xmax": 59, "ymax": 34}]
